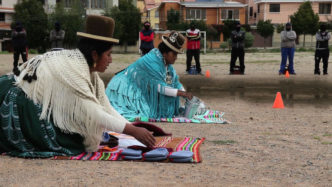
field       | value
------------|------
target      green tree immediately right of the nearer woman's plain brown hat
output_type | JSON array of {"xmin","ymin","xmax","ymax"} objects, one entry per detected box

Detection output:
[{"xmin": 105, "ymin": 0, "xmax": 141, "ymax": 52}]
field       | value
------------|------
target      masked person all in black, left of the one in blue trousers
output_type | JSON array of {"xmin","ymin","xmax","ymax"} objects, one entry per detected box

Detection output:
[{"xmin": 230, "ymin": 22, "xmax": 246, "ymax": 75}]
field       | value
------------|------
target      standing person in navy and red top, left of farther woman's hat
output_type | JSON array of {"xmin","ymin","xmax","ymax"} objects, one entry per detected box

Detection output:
[{"xmin": 139, "ymin": 21, "xmax": 154, "ymax": 56}]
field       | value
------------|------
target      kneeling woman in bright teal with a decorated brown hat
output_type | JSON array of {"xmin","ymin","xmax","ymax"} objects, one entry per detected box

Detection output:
[{"xmin": 106, "ymin": 32, "xmax": 192, "ymax": 119}]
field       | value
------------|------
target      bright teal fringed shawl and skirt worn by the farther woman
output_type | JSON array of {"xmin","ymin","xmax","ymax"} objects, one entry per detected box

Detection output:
[{"xmin": 106, "ymin": 49, "xmax": 182, "ymax": 119}]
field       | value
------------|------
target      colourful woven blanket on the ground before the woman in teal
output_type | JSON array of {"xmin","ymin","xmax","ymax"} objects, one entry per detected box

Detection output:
[{"xmin": 128, "ymin": 110, "xmax": 229, "ymax": 124}]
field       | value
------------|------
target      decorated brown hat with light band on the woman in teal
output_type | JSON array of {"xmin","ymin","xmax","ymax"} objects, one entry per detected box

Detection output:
[{"xmin": 161, "ymin": 31, "xmax": 186, "ymax": 53}]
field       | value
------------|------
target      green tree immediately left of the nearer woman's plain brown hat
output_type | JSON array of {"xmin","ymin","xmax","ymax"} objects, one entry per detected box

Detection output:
[{"xmin": 49, "ymin": 0, "xmax": 85, "ymax": 48}]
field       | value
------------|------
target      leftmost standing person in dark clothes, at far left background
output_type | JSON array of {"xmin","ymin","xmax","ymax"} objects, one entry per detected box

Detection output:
[{"xmin": 12, "ymin": 21, "xmax": 27, "ymax": 75}]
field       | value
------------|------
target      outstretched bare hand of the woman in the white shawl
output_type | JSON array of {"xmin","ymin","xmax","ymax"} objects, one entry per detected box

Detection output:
[{"xmin": 123, "ymin": 123, "xmax": 156, "ymax": 147}]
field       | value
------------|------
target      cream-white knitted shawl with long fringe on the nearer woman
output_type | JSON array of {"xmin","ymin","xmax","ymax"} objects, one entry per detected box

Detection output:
[{"xmin": 17, "ymin": 49, "xmax": 124, "ymax": 151}]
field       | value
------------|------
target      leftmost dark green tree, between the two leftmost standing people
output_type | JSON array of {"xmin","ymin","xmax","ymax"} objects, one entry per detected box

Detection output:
[{"xmin": 13, "ymin": 0, "xmax": 47, "ymax": 52}]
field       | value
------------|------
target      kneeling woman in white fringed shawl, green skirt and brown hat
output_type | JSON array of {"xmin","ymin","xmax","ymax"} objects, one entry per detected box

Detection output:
[{"xmin": 0, "ymin": 16, "xmax": 155, "ymax": 157}]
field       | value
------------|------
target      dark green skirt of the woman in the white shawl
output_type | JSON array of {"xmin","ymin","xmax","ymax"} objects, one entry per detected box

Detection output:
[{"xmin": 0, "ymin": 75, "xmax": 84, "ymax": 158}]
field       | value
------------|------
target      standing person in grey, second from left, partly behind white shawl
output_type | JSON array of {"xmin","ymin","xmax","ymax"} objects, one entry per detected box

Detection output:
[{"xmin": 50, "ymin": 22, "xmax": 66, "ymax": 51}]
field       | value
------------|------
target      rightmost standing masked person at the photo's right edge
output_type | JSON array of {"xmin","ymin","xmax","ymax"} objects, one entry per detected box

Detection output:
[{"xmin": 314, "ymin": 24, "xmax": 331, "ymax": 75}]
